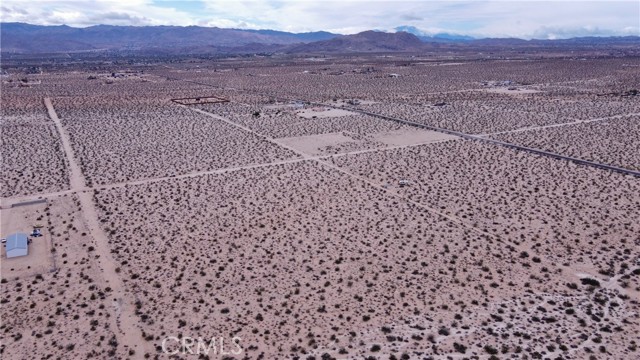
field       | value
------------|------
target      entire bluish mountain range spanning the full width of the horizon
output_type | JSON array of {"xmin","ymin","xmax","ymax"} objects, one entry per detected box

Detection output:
[{"xmin": 0, "ymin": 23, "xmax": 640, "ymax": 54}]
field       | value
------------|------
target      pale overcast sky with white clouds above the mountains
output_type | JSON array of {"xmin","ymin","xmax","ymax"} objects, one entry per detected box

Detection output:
[{"xmin": 0, "ymin": 0, "xmax": 640, "ymax": 39}]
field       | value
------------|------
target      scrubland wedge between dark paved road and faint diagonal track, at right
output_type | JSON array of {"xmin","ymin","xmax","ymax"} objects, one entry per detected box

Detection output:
[{"xmin": 334, "ymin": 141, "xmax": 640, "ymax": 273}]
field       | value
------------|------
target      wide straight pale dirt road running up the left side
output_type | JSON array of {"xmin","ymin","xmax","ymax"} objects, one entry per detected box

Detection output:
[{"xmin": 44, "ymin": 98, "xmax": 153, "ymax": 359}]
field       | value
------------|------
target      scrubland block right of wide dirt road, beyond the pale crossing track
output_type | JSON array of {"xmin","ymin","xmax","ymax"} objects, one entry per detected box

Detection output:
[{"xmin": 54, "ymin": 98, "xmax": 295, "ymax": 184}]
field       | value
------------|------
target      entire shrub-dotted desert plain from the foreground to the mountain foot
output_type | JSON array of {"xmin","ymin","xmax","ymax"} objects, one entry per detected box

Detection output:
[{"xmin": 0, "ymin": 55, "xmax": 640, "ymax": 360}]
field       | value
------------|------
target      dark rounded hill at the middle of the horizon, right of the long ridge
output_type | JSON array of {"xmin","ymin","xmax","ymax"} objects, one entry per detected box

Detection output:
[{"xmin": 288, "ymin": 31, "xmax": 425, "ymax": 53}]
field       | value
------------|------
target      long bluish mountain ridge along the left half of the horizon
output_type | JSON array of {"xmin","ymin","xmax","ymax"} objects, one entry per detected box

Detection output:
[{"xmin": 0, "ymin": 23, "xmax": 337, "ymax": 53}]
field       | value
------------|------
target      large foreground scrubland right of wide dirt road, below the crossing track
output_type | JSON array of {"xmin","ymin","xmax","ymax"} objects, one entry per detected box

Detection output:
[{"xmin": 97, "ymin": 161, "xmax": 638, "ymax": 358}]
